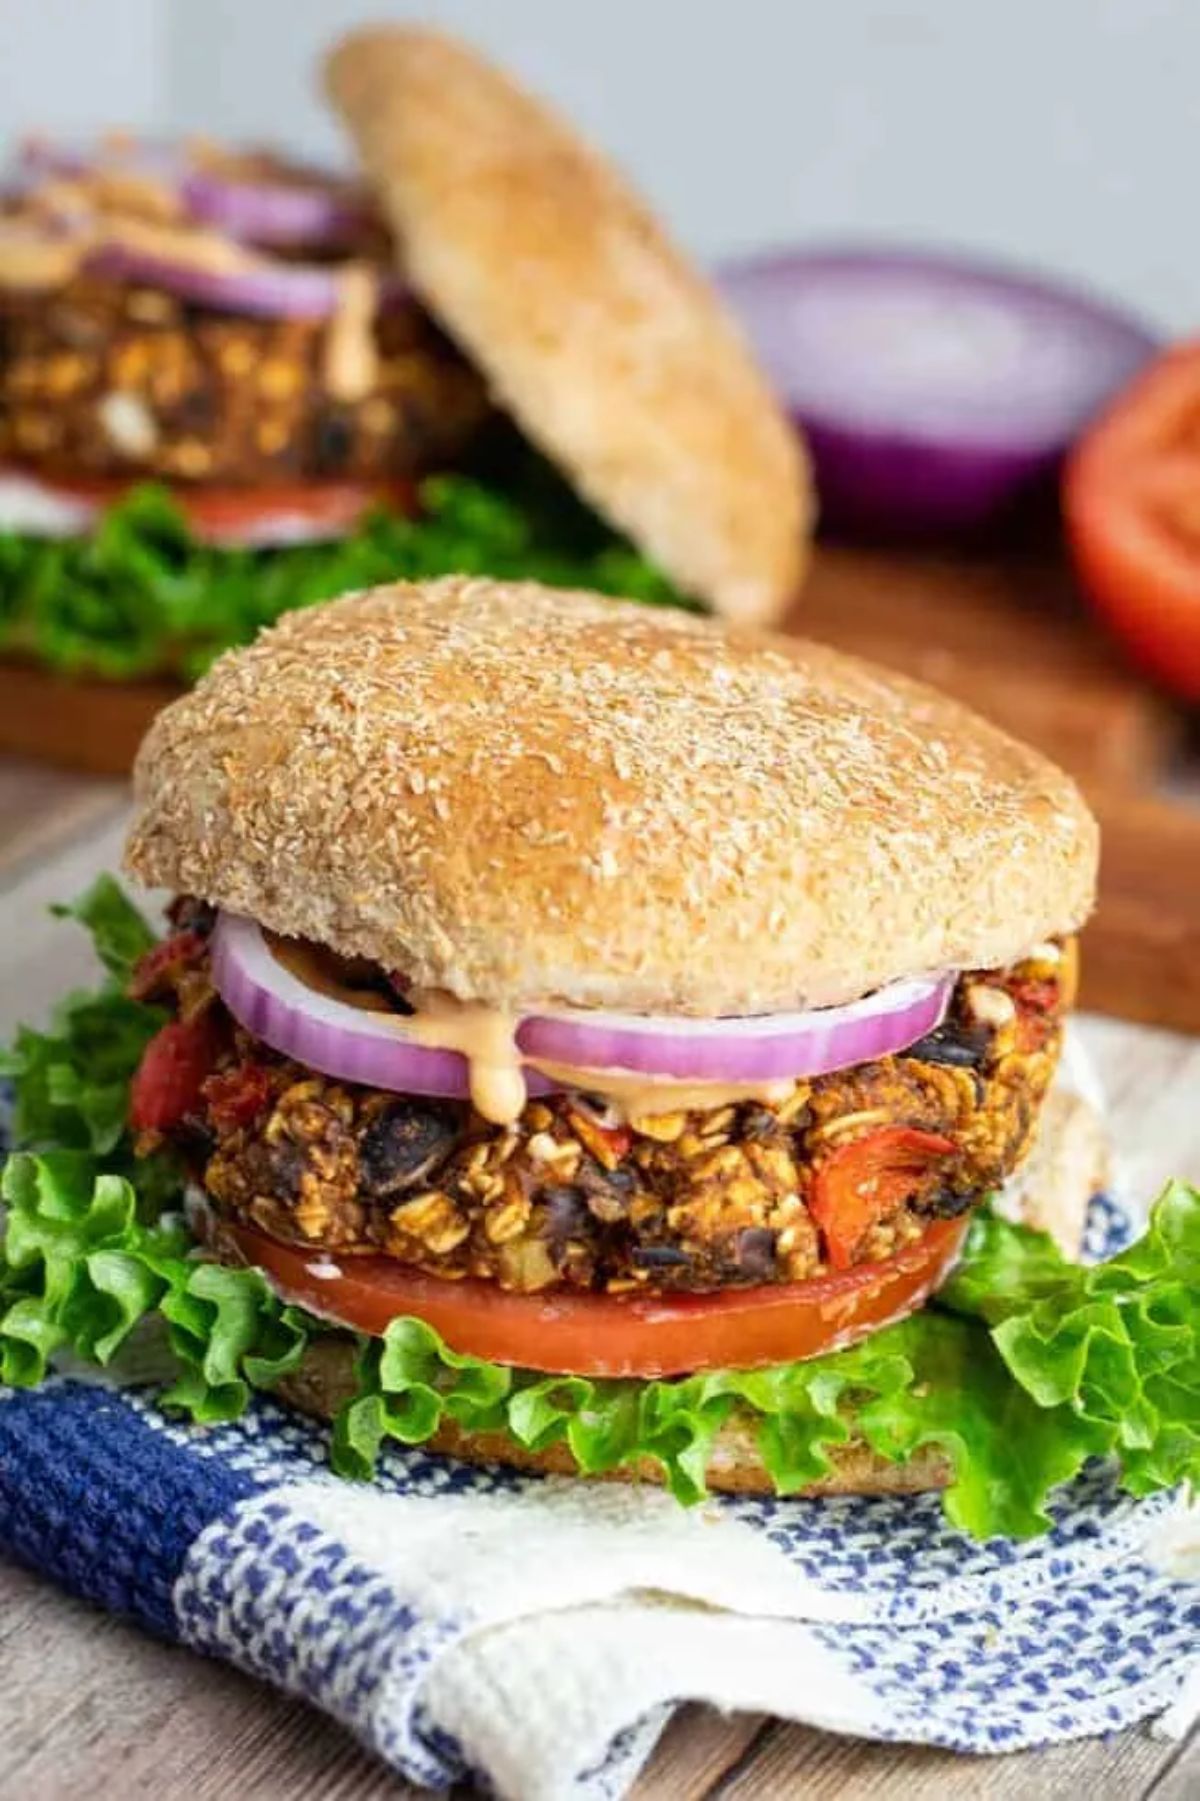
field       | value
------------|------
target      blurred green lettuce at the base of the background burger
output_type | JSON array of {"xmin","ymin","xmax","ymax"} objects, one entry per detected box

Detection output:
[{"xmin": 0, "ymin": 454, "xmax": 685, "ymax": 681}]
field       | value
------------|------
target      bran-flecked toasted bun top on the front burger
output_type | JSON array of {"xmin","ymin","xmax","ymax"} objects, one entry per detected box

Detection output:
[{"xmin": 126, "ymin": 576, "xmax": 1097, "ymax": 1016}]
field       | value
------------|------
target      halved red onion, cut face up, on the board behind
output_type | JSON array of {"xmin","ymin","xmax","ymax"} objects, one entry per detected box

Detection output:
[{"xmin": 719, "ymin": 247, "xmax": 1157, "ymax": 533}]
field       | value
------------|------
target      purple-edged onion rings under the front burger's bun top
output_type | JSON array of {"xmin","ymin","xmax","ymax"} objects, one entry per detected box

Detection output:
[{"xmin": 213, "ymin": 913, "xmax": 953, "ymax": 1097}]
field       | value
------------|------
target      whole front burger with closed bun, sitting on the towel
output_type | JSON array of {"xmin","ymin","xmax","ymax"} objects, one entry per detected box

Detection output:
[{"xmin": 0, "ymin": 576, "xmax": 1200, "ymax": 1536}]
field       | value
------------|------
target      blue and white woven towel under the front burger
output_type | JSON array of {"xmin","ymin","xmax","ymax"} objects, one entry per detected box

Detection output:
[{"xmin": 0, "ymin": 1203, "xmax": 1200, "ymax": 1801}]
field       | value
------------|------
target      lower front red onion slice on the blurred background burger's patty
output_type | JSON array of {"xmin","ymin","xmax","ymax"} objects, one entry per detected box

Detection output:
[{"xmin": 86, "ymin": 243, "xmax": 405, "ymax": 319}]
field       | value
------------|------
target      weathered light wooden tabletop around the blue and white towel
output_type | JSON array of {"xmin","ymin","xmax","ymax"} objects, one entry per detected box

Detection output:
[{"xmin": 0, "ymin": 760, "xmax": 1200, "ymax": 1801}]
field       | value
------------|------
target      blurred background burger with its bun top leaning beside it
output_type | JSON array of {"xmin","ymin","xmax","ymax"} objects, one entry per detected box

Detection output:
[{"xmin": 0, "ymin": 29, "xmax": 811, "ymax": 677}]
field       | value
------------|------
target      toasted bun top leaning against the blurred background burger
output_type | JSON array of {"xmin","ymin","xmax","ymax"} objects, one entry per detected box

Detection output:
[{"xmin": 326, "ymin": 17, "xmax": 813, "ymax": 621}]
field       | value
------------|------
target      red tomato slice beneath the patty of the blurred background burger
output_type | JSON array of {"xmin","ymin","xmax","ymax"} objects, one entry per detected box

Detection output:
[{"xmin": 4, "ymin": 470, "xmax": 416, "ymax": 546}]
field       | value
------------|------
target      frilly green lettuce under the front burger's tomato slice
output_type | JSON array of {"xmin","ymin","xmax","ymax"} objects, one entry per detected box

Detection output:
[{"xmin": 0, "ymin": 877, "xmax": 1200, "ymax": 1538}]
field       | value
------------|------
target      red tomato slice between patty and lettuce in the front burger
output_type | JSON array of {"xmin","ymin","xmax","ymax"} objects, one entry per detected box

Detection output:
[{"xmin": 213, "ymin": 1219, "xmax": 968, "ymax": 1378}]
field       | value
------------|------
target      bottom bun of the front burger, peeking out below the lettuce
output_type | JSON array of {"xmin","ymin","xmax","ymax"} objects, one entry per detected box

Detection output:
[{"xmin": 274, "ymin": 1338, "xmax": 951, "ymax": 1497}]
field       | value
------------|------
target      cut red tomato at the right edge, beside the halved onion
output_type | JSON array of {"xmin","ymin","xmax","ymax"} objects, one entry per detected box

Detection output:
[{"xmin": 1063, "ymin": 342, "xmax": 1200, "ymax": 701}]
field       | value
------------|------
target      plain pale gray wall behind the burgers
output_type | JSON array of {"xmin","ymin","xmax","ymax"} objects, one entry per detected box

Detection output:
[{"xmin": 0, "ymin": 0, "xmax": 1200, "ymax": 330}]
